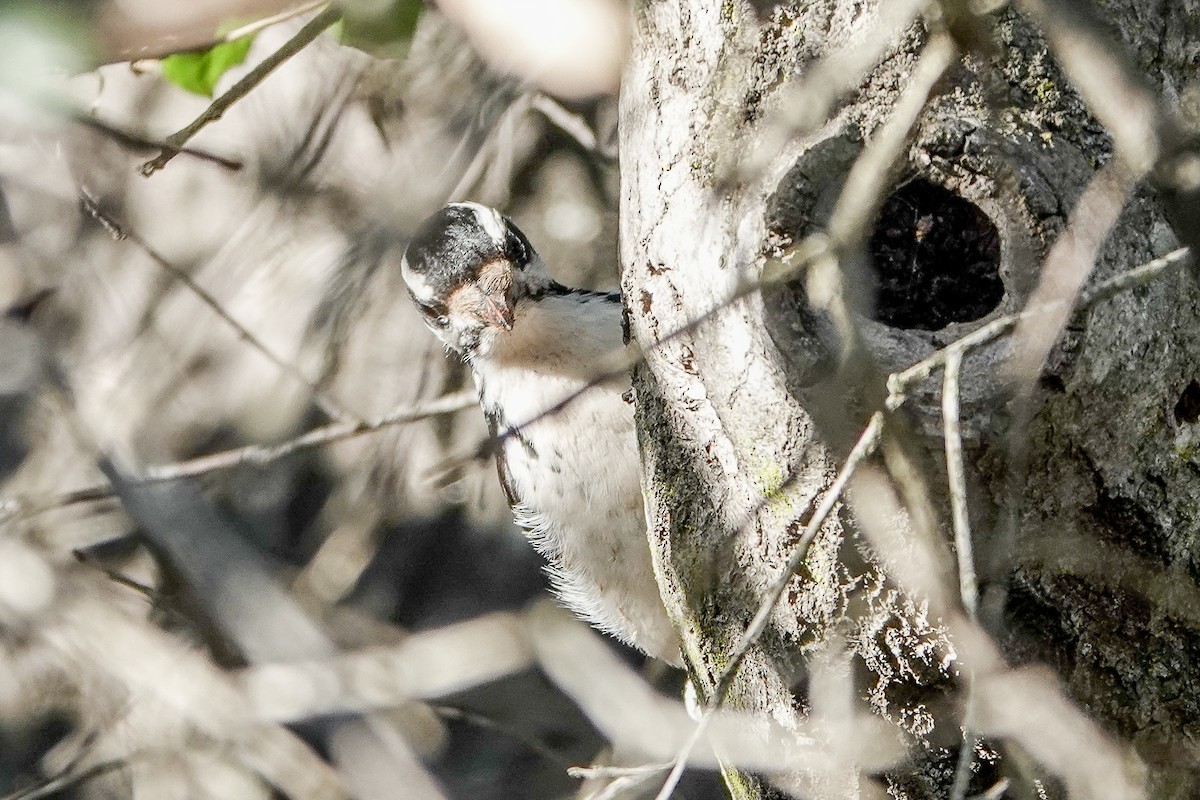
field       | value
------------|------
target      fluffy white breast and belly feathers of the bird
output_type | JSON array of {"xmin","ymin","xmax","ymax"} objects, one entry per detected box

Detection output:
[{"xmin": 472, "ymin": 298, "xmax": 678, "ymax": 661}]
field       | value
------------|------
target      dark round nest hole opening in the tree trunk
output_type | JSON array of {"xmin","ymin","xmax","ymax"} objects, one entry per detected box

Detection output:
[{"xmin": 870, "ymin": 179, "xmax": 1004, "ymax": 331}]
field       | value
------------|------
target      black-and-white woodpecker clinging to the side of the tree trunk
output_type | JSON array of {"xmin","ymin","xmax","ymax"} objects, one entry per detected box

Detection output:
[{"xmin": 402, "ymin": 203, "xmax": 679, "ymax": 662}]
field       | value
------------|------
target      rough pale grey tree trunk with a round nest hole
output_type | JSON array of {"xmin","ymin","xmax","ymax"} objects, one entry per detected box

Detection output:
[{"xmin": 620, "ymin": 0, "xmax": 1200, "ymax": 798}]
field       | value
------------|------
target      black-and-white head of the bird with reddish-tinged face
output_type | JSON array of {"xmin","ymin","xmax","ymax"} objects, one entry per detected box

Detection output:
[{"xmin": 401, "ymin": 203, "xmax": 553, "ymax": 357}]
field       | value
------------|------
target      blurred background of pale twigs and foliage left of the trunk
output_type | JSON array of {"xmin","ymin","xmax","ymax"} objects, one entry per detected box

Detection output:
[{"xmin": 0, "ymin": 0, "xmax": 716, "ymax": 798}]
